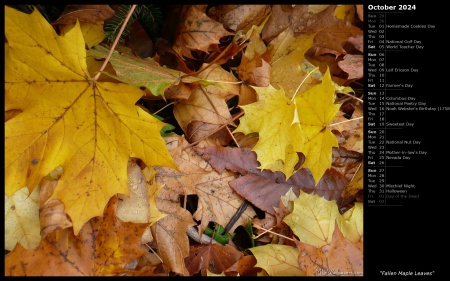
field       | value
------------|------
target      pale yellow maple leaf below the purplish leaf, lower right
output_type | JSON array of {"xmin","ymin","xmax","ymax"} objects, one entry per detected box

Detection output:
[{"xmin": 283, "ymin": 190, "xmax": 339, "ymax": 247}]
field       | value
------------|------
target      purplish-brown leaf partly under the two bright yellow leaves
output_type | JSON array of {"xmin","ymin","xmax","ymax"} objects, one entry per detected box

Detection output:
[{"xmin": 194, "ymin": 146, "xmax": 348, "ymax": 215}]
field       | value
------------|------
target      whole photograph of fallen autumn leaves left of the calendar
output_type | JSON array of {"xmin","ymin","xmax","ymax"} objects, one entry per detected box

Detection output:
[{"xmin": 4, "ymin": 5, "xmax": 364, "ymax": 276}]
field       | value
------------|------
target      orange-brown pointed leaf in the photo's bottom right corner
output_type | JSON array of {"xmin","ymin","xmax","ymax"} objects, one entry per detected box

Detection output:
[{"xmin": 297, "ymin": 224, "xmax": 363, "ymax": 276}]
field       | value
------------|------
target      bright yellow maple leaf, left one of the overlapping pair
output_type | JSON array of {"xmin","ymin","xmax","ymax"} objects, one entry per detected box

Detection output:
[{"xmin": 234, "ymin": 85, "xmax": 304, "ymax": 178}]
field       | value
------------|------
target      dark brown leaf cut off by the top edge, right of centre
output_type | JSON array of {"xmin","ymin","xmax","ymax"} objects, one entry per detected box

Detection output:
[{"xmin": 208, "ymin": 5, "xmax": 270, "ymax": 34}]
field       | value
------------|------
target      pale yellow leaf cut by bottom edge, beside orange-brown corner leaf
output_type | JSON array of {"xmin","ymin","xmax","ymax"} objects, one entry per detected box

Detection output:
[{"xmin": 249, "ymin": 244, "xmax": 306, "ymax": 276}]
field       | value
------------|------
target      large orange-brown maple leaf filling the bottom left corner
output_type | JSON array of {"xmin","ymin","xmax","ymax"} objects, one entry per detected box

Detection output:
[{"xmin": 5, "ymin": 196, "xmax": 147, "ymax": 276}]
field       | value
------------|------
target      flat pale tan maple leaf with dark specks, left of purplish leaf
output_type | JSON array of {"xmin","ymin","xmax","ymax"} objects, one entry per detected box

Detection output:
[{"xmin": 156, "ymin": 137, "xmax": 256, "ymax": 233}]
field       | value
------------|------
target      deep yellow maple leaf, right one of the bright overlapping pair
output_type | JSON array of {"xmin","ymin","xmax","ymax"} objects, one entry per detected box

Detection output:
[{"xmin": 295, "ymin": 69, "xmax": 341, "ymax": 183}]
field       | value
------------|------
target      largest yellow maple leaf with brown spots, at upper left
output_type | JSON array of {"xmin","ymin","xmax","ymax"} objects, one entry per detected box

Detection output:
[{"xmin": 5, "ymin": 7, "xmax": 176, "ymax": 235}]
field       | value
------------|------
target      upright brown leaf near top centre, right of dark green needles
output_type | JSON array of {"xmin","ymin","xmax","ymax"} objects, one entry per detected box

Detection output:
[{"xmin": 173, "ymin": 5, "xmax": 232, "ymax": 59}]
